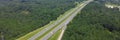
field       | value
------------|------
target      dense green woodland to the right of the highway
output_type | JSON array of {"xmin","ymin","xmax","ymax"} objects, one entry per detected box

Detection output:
[{"xmin": 62, "ymin": 1, "xmax": 120, "ymax": 40}]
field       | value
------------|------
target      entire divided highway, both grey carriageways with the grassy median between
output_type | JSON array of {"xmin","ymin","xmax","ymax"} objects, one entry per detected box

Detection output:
[{"xmin": 28, "ymin": 0, "xmax": 91, "ymax": 40}]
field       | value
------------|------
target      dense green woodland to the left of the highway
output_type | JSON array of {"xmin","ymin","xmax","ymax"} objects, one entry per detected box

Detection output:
[{"xmin": 0, "ymin": 0, "xmax": 83, "ymax": 40}]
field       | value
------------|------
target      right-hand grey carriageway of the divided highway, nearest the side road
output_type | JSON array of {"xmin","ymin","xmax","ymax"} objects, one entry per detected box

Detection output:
[{"xmin": 40, "ymin": 0, "xmax": 93, "ymax": 40}]
